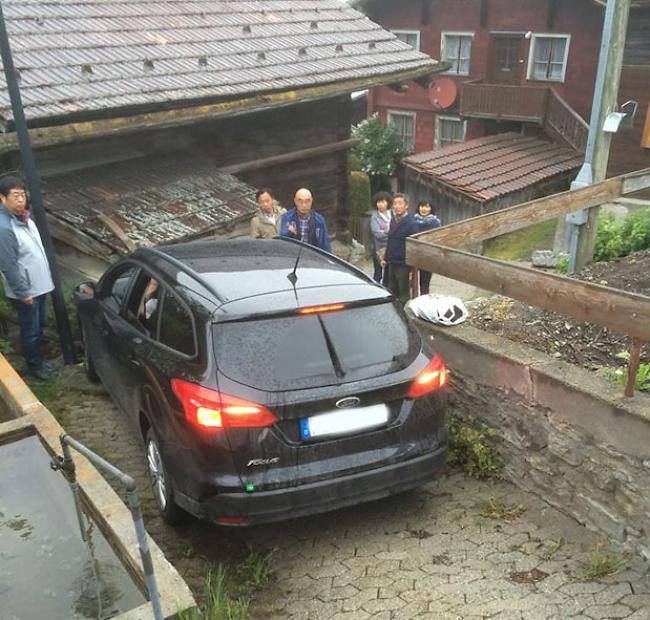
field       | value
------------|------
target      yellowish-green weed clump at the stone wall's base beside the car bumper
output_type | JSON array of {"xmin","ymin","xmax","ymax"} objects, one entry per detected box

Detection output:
[{"xmin": 447, "ymin": 415, "xmax": 503, "ymax": 480}]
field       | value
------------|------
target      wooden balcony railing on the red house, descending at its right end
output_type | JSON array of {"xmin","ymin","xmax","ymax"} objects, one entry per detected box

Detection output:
[{"xmin": 460, "ymin": 80, "xmax": 589, "ymax": 152}]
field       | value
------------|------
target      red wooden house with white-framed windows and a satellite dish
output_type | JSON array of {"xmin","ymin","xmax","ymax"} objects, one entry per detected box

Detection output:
[{"xmin": 353, "ymin": 0, "xmax": 650, "ymax": 176}]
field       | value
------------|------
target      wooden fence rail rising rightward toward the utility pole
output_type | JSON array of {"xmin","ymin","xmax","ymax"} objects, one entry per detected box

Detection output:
[{"xmin": 416, "ymin": 170, "xmax": 620, "ymax": 248}]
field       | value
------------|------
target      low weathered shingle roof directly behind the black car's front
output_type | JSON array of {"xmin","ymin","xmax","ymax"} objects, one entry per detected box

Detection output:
[{"xmin": 43, "ymin": 158, "xmax": 257, "ymax": 254}]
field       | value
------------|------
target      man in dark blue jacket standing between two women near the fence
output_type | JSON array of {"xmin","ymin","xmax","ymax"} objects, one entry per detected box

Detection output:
[{"xmin": 385, "ymin": 194, "xmax": 418, "ymax": 304}]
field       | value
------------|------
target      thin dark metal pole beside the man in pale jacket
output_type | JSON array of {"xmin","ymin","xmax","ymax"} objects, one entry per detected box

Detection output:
[{"xmin": 0, "ymin": 2, "xmax": 76, "ymax": 364}]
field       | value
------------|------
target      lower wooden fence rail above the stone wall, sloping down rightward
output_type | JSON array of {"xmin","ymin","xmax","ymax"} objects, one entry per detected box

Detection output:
[{"xmin": 406, "ymin": 237, "xmax": 650, "ymax": 341}]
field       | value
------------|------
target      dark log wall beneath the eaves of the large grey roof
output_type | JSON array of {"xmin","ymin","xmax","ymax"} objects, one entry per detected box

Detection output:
[{"xmin": 30, "ymin": 95, "xmax": 351, "ymax": 228}]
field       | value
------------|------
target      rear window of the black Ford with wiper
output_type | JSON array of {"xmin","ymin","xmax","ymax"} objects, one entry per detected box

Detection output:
[{"xmin": 213, "ymin": 303, "xmax": 419, "ymax": 391}]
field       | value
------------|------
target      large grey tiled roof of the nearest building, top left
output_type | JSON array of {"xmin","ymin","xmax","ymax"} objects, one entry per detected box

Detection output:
[{"xmin": 0, "ymin": 0, "xmax": 436, "ymax": 126}]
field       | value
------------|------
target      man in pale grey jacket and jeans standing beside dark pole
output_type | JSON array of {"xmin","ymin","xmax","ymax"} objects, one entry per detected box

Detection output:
[{"xmin": 0, "ymin": 176, "xmax": 54, "ymax": 379}]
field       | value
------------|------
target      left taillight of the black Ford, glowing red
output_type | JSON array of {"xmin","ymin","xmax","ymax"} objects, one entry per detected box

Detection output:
[{"xmin": 172, "ymin": 379, "xmax": 277, "ymax": 429}]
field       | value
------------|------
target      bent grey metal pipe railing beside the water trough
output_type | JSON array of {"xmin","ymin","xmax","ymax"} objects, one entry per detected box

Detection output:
[{"xmin": 53, "ymin": 433, "xmax": 164, "ymax": 620}]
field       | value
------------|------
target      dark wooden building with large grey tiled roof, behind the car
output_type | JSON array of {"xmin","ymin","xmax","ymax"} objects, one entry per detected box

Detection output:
[{"xmin": 0, "ymin": 0, "xmax": 437, "ymax": 272}]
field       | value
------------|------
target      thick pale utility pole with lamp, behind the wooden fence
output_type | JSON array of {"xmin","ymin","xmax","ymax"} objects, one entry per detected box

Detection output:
[{"xmin": 566, "ymin": 0, "xmax": 631, "ymax": 273}]
